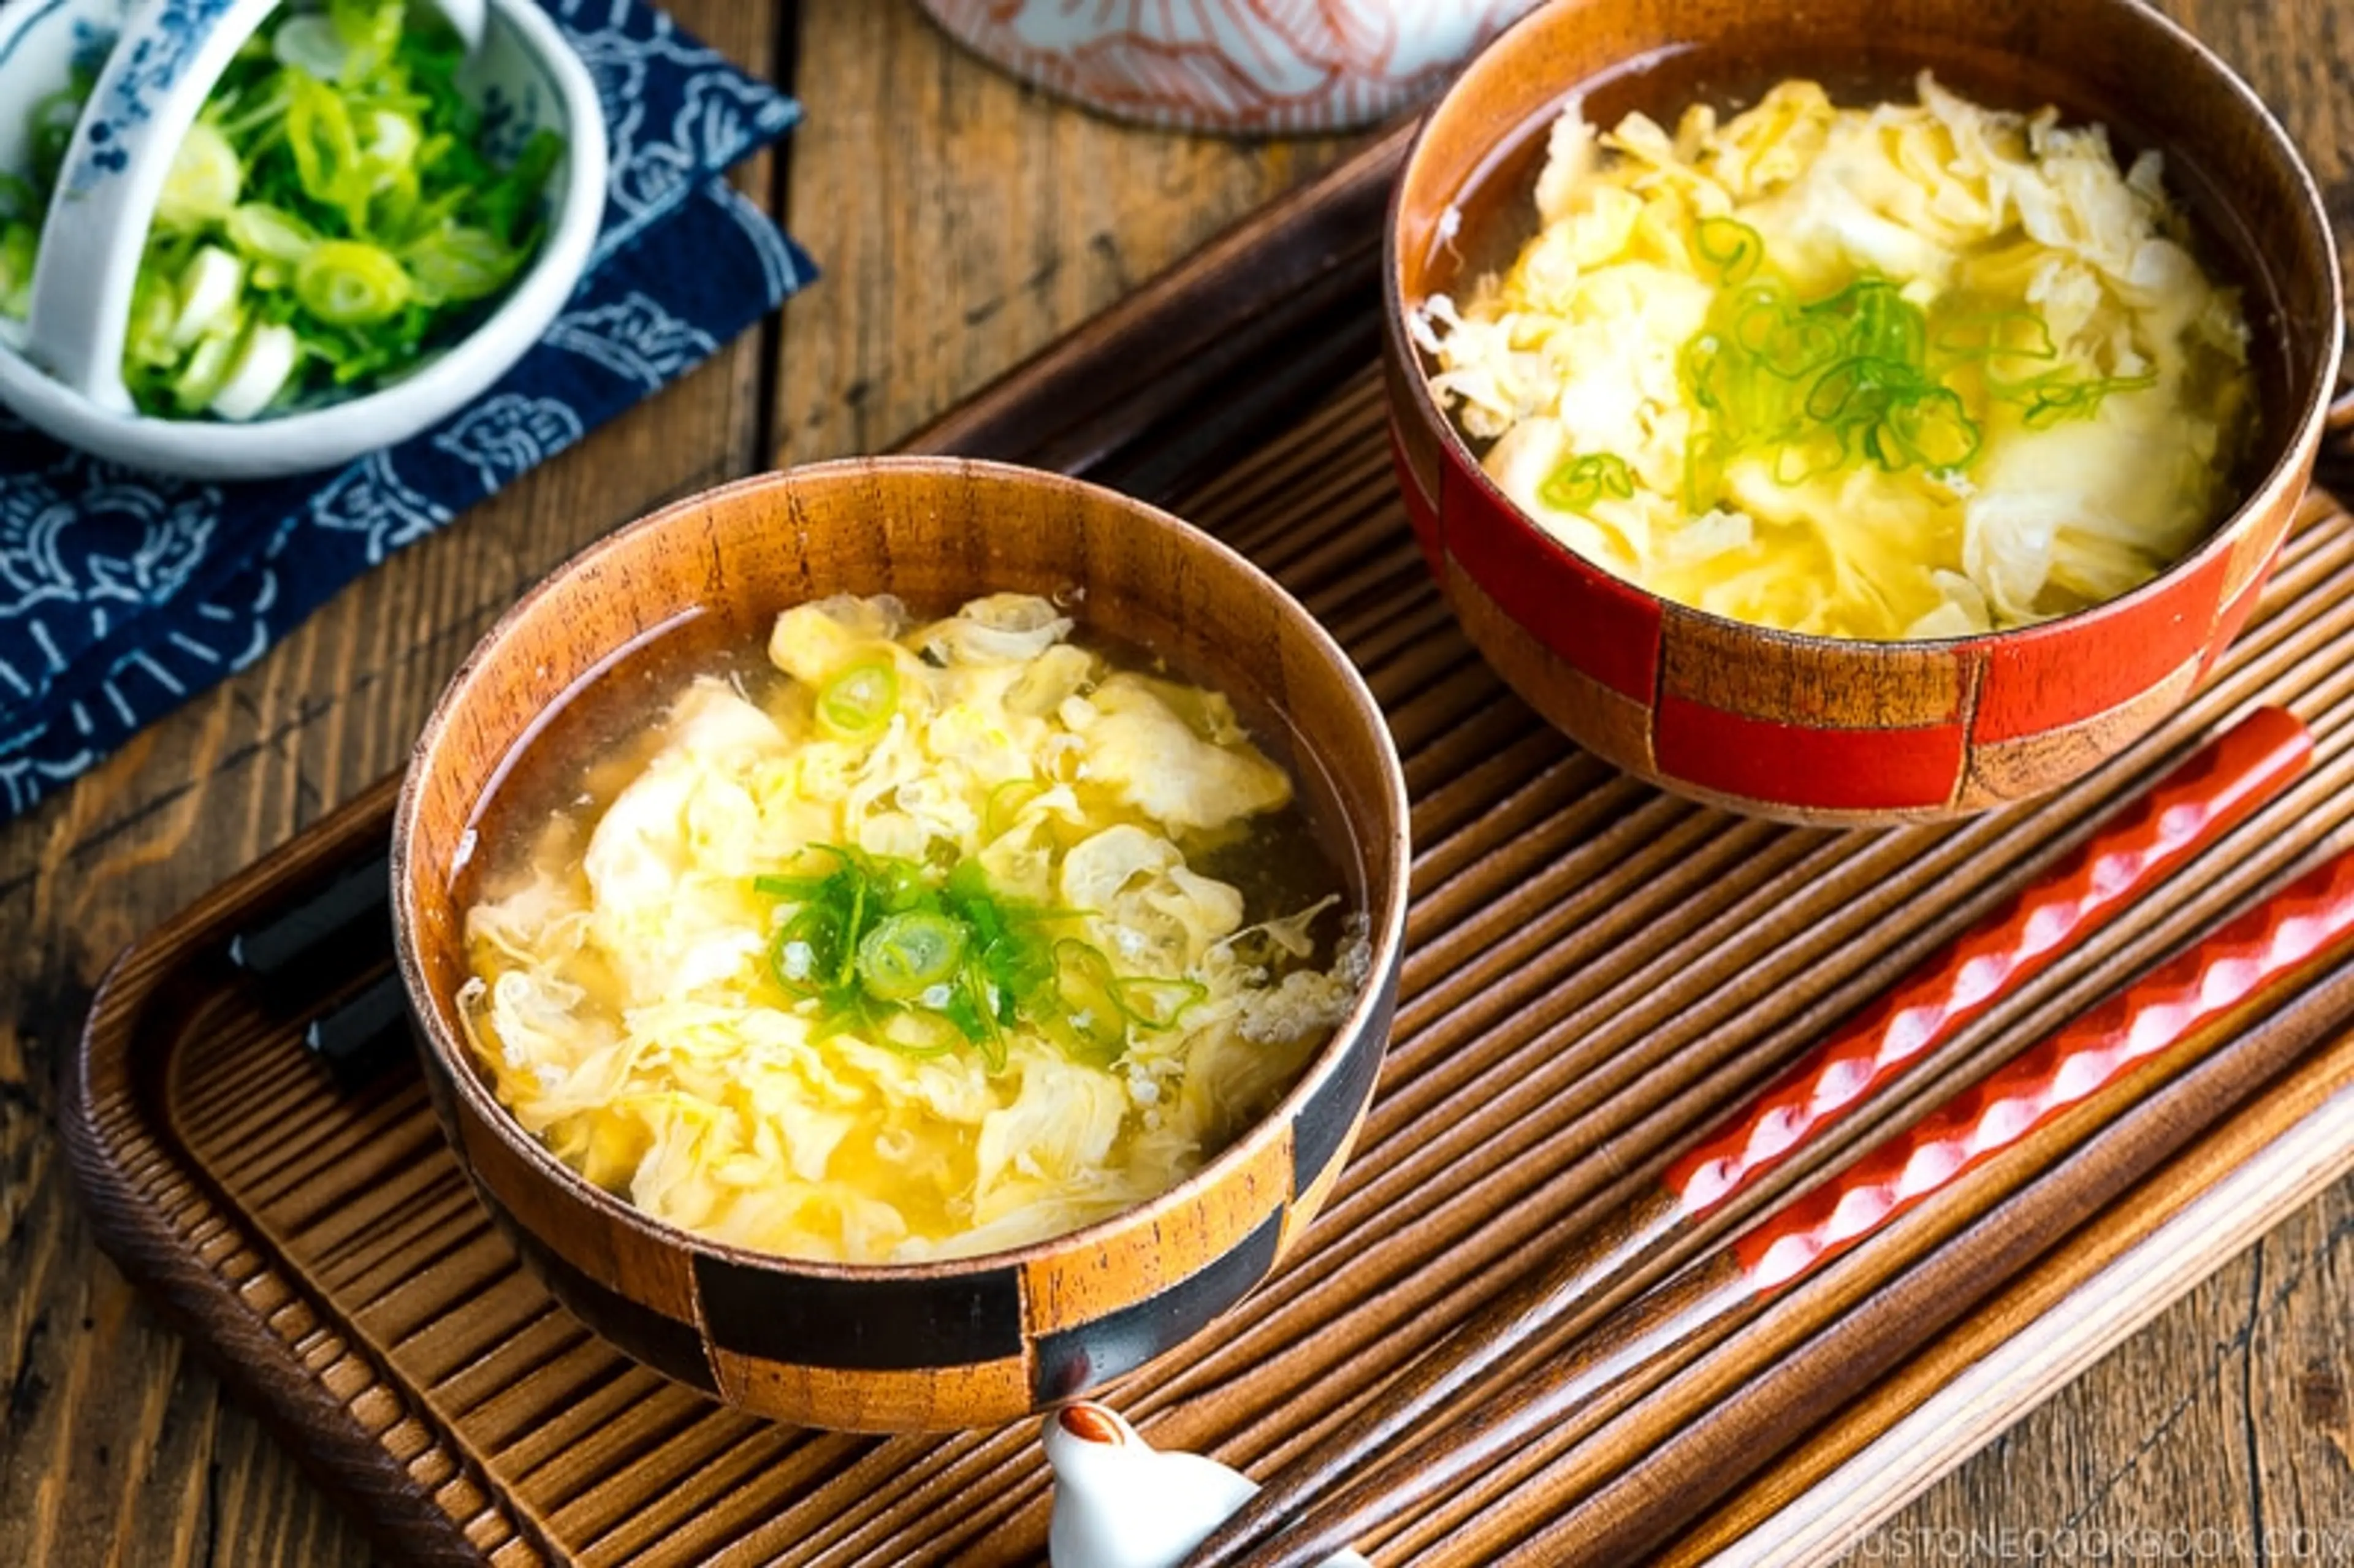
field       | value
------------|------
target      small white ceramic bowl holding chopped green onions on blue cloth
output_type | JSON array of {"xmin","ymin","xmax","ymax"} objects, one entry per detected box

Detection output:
[{"xmin": 0, "ymin": 0, "xmax": 608, "ymax": 478}]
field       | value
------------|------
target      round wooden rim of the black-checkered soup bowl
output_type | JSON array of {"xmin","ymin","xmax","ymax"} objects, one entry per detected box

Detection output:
[{"xmin": 390, "ymin": 457, "xmax": 1410, "ymax": 1283}]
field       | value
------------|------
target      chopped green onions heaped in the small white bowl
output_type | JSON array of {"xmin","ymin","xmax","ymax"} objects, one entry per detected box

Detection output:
[{"xmin": 0, "ymin": 0, "xmax": 563, "ymax": 419}]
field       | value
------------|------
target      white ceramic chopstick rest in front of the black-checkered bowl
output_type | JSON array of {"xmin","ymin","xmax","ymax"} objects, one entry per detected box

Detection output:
[{"xmin": 1043, "ymin": 1401, "xmax": 1373, "ymax": 1568}]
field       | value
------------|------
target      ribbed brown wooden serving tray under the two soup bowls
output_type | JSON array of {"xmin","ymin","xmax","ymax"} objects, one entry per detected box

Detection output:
[{"xmin": 61, "ymin": 128, "xmax": 2354, "ymax": 1563}]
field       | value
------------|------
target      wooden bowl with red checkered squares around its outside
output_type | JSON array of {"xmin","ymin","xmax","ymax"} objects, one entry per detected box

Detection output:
[{"xmin": 1387, "ymin": 0, "xmax": 2340, "ymax": 824}]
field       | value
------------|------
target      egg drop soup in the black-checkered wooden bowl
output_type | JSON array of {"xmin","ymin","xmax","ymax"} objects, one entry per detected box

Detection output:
[{"xmin": 459, "ymin": 596, "xmax": 1370, "ymax": 1262}]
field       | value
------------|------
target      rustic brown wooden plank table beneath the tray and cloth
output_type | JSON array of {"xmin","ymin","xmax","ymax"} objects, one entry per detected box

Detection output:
[{"xmin": 0, "ymin": 0, "xmax": 2354, "ymax": 1566}]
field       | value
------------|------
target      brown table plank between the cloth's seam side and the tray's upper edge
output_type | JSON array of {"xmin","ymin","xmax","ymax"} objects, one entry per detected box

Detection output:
[{"xmin": 772, "ymin": 0, "xmax": 1351, "ymax": 466}]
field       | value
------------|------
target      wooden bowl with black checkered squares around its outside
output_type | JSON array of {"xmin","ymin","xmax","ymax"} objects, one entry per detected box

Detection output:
[{"xmin": 393, "ymin": 459, "xmax": 1407, "ymax": 1431}]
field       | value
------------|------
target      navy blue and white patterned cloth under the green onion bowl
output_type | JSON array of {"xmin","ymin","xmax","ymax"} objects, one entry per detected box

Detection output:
[{"xmin": 0, "ymin": 0, "xmax": 815, "ymax": 820}]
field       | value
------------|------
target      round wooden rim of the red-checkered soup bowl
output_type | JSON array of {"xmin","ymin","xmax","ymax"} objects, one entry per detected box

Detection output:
[{"xmin": 1382, "ymin": 0, "xmax": 2347, "ymax": 659}]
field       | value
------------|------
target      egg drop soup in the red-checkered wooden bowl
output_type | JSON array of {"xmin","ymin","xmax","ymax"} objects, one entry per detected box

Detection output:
[{"xmin": 1410, "ymin": 73, "xmax": 2255, "ymax": 641}]
